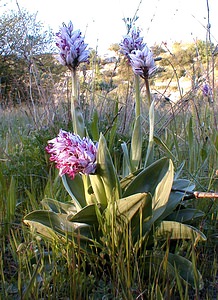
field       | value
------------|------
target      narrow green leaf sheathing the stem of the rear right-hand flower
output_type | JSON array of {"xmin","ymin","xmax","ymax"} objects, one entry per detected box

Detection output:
[{"xmin": 130, "ymin": 116, "xmax": 142, "ymax": 171}]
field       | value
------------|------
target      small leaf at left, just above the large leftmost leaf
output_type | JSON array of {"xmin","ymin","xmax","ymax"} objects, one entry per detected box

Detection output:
[{"xmin": 41, "ymin": 198, "xmax": 76, "ymax": 215}]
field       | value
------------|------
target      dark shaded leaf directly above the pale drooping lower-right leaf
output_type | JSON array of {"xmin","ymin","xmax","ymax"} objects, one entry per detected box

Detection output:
[{"xmin": 166, "ymin": 208, "xmax": 205, "ymax": 223}]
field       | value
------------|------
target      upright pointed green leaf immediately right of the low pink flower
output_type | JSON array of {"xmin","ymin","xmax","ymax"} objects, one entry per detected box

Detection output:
[{"xmin": 96, "ymin": 134, "xmax": 121, "ymax": 202}]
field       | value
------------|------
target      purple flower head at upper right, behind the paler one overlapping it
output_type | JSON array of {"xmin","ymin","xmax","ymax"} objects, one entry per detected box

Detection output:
[{"xmin": 119, "ymin": 28, "xmax": 145, "ymax": 58}]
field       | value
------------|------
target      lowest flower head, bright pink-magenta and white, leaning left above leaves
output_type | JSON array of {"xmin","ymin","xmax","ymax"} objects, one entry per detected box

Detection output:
[{"xmin": 46, "ymin": 130, "xmax": 97, "ymax": 179}]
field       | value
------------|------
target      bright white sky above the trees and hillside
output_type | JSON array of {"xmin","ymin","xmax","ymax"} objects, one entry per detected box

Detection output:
[{"xmin": 0, "ymin": 0, "xmax": 218, "ymax": 54}]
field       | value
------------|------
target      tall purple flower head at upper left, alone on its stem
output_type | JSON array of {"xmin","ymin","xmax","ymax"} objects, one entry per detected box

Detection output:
[{"xmin": 56, "ymin": 22, "xmax": 90, "ymax": 70}]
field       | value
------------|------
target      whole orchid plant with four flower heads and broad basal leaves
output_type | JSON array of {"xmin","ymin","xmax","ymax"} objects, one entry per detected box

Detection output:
[{"xmin": 24, "ymin": 23, "xmax": 206, "ymax": 287}]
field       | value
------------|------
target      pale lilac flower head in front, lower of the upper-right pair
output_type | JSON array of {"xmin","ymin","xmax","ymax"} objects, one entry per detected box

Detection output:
[{"xmin": 129, "ymin": 45, "xmax": 157, "ymax": 79}]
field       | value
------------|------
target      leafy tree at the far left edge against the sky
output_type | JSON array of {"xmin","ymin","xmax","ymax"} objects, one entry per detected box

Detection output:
[{"xmin": 0, "ymin": 10, "xmax": 54, "ymax": 107}]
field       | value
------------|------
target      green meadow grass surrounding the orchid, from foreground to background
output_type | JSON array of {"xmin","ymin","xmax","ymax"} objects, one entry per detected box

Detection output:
[{"xmin": 0, "ymin": 39, "xmax": 218, "ymax": 300}]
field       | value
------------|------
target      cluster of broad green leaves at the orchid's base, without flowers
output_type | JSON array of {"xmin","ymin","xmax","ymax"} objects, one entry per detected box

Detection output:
[{"xmin": 24, "ymin": 132, "xmax": 206, "ymax": 286}]
